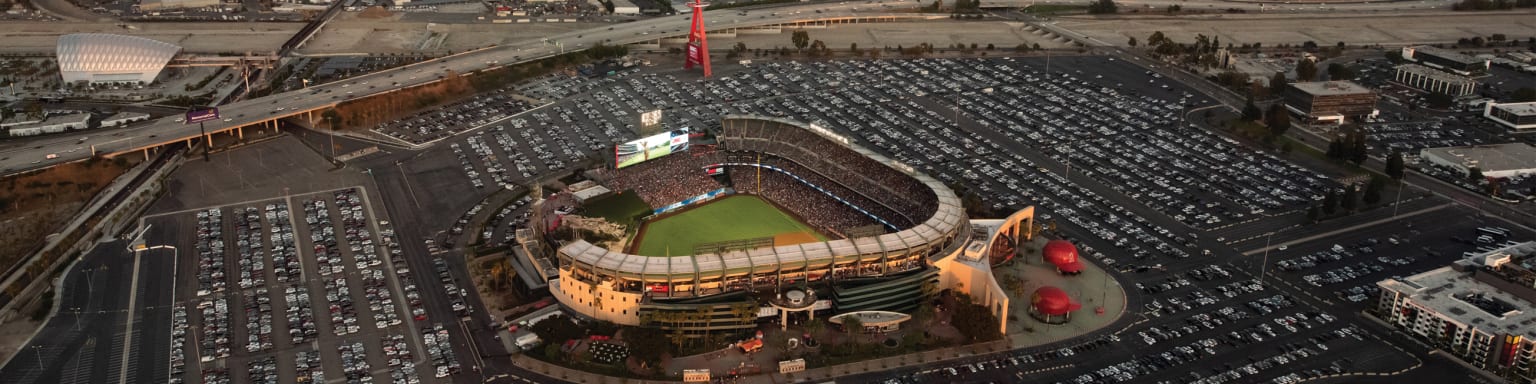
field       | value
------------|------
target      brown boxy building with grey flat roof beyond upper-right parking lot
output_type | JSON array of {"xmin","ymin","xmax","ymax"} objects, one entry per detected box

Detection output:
[{"xmin": 1284, "ymin": 81, "xmax": 1378, "ymax": 124}]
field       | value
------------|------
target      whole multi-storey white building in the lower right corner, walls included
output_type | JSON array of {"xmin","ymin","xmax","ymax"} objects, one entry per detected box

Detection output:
[{"xmin": 1375, "ymin": 243, "xmax": 1536, "ymax": 384}]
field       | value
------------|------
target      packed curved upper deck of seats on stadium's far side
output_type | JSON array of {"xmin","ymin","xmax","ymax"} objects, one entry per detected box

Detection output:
[{"xmin": 720, "ymin": 120, "xmax": 938, "ymax": 227}]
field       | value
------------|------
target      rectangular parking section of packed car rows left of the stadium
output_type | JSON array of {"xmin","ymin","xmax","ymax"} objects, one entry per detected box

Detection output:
[{"xmin": 149, "ymin": 187, "xmax": 441, "ymax": 384}]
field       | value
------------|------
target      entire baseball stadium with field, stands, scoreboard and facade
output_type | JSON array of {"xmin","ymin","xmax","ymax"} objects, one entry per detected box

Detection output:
[{"xmin": 542, "ymin": 115, "xmax": 1034, "ymax": 333}]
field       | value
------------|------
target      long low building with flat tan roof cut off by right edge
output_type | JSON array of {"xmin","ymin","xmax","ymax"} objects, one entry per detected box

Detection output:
[{"xmin": 1419, "ymin": 143, "xmax": 1536, "ymax": 177}]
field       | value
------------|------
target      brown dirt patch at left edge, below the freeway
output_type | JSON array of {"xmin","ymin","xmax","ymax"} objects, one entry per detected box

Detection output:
[{"xmin": 0, "ymin": 157, "xmax": 137, "ymax": 270}]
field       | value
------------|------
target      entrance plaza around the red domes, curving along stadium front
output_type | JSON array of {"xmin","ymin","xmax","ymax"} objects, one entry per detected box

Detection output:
[{"xmin": 648, "ymin": 238, "xmax": 1126, "ymax": 382}]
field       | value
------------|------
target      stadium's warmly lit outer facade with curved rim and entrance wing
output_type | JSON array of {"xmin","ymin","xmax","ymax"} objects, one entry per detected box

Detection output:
[{"xmin": 550, "ymin": 115, "xmax": 1034, "ymax": 335}]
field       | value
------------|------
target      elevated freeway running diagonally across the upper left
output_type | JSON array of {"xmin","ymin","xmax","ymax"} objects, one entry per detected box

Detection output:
[{"xmin": 0, "ymin": 3, "xmax": 948, "ymax": 175}]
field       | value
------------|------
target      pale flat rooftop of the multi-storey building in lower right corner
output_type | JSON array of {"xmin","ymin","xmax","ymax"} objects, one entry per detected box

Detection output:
[{"xmin": 1379, "ymin": 243, "xmax": 1536, "ymax": 338}]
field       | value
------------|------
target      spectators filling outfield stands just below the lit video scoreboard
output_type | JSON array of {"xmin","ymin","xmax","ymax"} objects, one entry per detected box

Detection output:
[{"xmin": 594, "ymin": 149, "xmax": 720, "ymax": 207}]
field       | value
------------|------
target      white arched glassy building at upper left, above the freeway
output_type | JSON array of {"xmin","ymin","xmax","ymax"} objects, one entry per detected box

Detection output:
[{"xmin": 57, "ymin": 34, "xmax": 181, "ymax": 84}]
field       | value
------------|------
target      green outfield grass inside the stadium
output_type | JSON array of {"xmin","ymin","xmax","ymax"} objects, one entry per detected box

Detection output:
[{"xmin": 636, "ymin": 195, "xmax": 826, "ymax": 257}]
